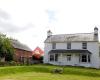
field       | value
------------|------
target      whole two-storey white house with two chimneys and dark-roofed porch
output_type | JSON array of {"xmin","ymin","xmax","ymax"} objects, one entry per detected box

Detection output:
[{"xmin": 44, "ymin": 27, "xmax": 100, "ymax": 68}]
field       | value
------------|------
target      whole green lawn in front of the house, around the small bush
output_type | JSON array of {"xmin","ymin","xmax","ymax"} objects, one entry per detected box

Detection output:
[{"xmin": 0, "ymin": 65, "xmax": 100, "ymax": 80}]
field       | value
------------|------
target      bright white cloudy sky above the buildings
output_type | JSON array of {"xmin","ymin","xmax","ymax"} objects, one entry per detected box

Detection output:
[{"xmin": 0, "ymin": 0, "xmax": 100, "ymax": 50}]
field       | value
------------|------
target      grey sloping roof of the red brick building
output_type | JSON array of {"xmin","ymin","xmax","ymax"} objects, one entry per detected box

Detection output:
[{"xmin": 11, "ymin": 40, "xmax": 32, "ymax": 51}]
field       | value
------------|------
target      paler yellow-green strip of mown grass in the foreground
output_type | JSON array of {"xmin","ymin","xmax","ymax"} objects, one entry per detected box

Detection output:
[{"xmin": 0, "ymin": 72, "xmax": 100, "ymax": 80}]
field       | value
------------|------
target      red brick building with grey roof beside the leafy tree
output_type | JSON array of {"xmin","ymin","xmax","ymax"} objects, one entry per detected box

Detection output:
[{"xmin": 11, "ymin": 40, "xmax": 32, "ymax": 63}]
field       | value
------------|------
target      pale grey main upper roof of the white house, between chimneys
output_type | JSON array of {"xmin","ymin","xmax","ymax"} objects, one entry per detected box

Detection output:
[{"xmin": 45, "ymin": 33, "xmax": 95, "ymax": 43}]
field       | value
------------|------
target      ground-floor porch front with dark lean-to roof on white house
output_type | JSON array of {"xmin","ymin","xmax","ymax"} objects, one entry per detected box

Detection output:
[{"xmin": 48, "ymin": 50, "xmax": 91, "ymax": 67}]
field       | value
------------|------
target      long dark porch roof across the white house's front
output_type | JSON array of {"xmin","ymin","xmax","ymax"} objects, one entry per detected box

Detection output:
[{"xmin": 49, "ymin": 49, "xmax": 91, "ymax": 54}]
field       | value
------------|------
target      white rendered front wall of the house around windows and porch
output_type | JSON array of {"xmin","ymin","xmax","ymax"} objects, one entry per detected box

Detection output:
[{"xmin": 44, "ymin": 42, "xmax": 100, "ymax": 68}]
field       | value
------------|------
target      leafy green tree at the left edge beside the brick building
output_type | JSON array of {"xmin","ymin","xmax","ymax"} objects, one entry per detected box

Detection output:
[{"xmin": 0, "ymin": 34, "xmax": 14, "ymax": 61}]
